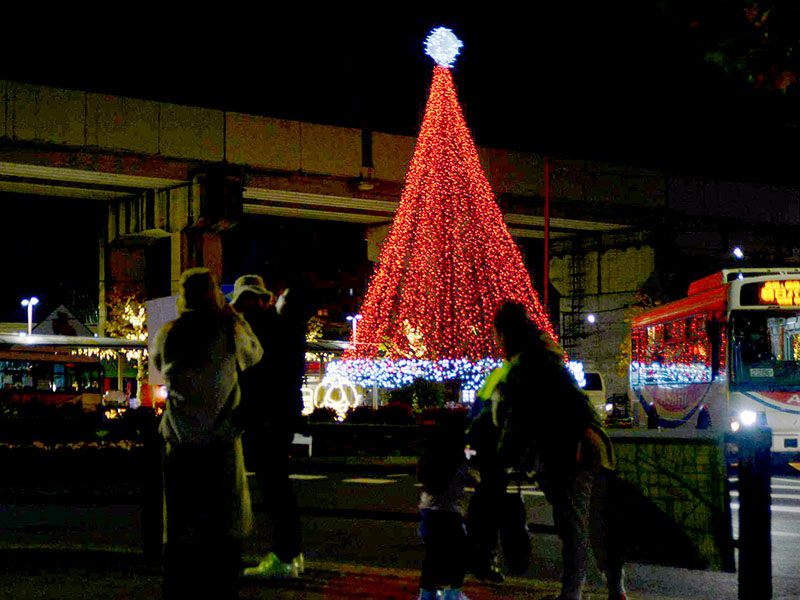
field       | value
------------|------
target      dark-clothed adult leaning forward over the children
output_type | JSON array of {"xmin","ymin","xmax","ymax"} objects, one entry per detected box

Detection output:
[{"xmin": 492, "ymin": 302, "xmax": 626, "ymax": 600}]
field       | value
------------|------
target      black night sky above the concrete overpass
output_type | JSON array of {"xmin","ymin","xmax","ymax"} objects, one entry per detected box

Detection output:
[{"xmin": 0, "ymin": 0, "xmax": 800, "ymax": 320}]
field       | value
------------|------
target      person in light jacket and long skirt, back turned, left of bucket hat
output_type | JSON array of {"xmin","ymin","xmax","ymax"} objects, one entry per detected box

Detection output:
[{"xmin": 153, "ymin": 268, "xmax": 263, "ymax": 600}]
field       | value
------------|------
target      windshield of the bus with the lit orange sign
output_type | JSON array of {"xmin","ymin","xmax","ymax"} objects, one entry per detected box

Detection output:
[{"xmin": 730, "ymin": 310, "xmax": 800, "ymax": 389}]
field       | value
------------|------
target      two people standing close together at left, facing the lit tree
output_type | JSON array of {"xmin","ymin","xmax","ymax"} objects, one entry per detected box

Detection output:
[{"xmin": 153, "ymin": 268, "xmax": 312, "ymax": 599}]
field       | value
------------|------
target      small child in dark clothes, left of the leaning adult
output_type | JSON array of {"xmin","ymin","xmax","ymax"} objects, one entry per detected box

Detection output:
[{"xmin": 417, "ymin": 413, "xmax": 475, "ymax": 600}]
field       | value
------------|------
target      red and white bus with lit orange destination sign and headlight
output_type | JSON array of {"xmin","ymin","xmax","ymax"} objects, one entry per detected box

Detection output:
[{"xmin": 628, "ymin": 268, "xmax": 800, "ymax": 460}]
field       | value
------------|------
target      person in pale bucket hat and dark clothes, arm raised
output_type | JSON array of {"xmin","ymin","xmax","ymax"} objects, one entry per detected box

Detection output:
[{"xmin": 231, "ymin": 275, "xmax": 311, "ymax": 577}]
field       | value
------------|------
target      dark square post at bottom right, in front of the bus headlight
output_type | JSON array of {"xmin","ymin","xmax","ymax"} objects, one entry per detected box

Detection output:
[{"xmin": 735, "ymin": 427, "xmax": 772, "ymax": 600}]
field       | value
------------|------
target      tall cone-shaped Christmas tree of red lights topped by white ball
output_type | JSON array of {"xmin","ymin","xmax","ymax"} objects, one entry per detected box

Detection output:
[{"xmin": 333, "ymin": 28, "xmax": 555, "ymax": 389}]
